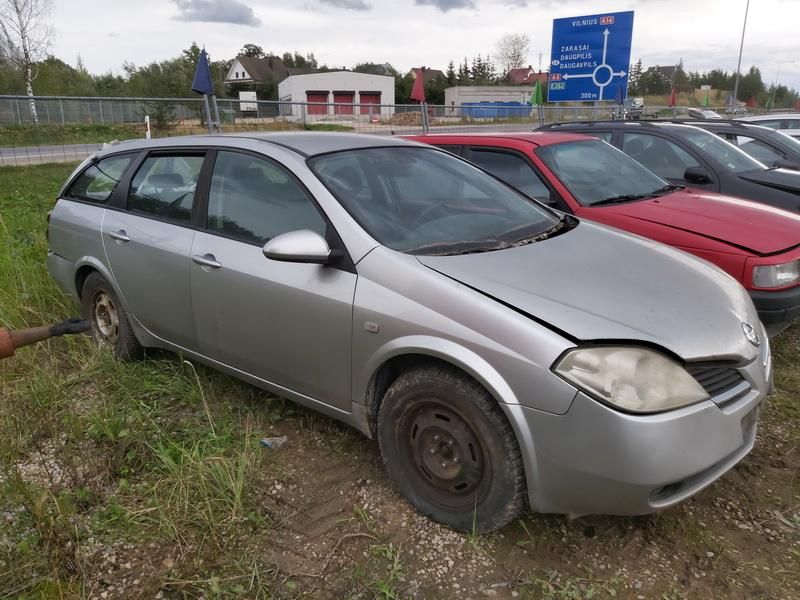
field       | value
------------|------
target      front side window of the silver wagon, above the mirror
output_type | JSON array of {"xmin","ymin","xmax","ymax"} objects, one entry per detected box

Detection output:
[{"xmin": 206, "ymin": 151, "xmax": 327, "ymax": 245}]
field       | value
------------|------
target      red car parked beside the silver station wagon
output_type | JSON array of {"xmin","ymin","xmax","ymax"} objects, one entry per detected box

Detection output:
[{"xmin": 409, "ymin": 132, "xmax": 800, "ymax": 335}]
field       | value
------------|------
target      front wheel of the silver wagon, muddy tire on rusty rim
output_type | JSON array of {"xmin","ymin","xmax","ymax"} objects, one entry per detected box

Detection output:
[{"xmin": 377, "ymin": 366, "xmax": 527, "ymax": 533}]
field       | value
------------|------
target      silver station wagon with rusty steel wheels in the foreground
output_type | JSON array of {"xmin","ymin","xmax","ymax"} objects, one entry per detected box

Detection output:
[{"xmin": 48, "ymin": 132, "xmax": 771, "ymax": 531}]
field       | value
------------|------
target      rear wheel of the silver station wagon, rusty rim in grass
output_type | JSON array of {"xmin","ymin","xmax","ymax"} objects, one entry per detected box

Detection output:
[{"xmin": 81, "ymin": 272, "xmax": 143, "ymax": 360}]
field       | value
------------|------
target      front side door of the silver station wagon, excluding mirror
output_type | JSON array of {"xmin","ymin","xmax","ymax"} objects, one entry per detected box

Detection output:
[{"xmin": 190, "ymin": 149, "xmax": 356, "ymax": 410}]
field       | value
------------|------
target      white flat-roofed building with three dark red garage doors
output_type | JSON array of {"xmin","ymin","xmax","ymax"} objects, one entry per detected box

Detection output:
[{"xmin": 278, "ymin": 71, "xmax": 394, "ymax": 118}]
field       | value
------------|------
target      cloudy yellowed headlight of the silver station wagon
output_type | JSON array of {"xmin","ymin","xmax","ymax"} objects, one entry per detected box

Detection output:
[{"xmin": 555, "ymin": 346, "xmax": 708, "ymax": 413}]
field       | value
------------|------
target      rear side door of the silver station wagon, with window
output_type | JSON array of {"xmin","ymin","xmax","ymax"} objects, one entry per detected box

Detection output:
[{"xmin": 101, "ymin": 151, "xmax": 205, "ymax": 350}]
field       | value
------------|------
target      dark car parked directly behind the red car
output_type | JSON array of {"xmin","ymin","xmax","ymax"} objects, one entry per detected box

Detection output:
[{"xmin": 539, "ymin": 121, "xmax": 800, "ymax": 212}]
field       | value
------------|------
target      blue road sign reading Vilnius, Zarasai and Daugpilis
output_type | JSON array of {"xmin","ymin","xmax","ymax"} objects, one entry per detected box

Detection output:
[{"xmin": 547, "ymin": 11, "xmax": 633, "ymax": 102}]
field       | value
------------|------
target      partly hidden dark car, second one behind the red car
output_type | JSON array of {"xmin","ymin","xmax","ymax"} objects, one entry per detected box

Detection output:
[{"xmin": 676, "ymin": 119, "xmax": 800, "ymax": 171}]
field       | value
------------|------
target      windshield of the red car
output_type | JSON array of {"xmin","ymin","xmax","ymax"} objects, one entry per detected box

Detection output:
[{"xmin": 536, "ymin": 140, "xmax": 676, "ymax": 206}]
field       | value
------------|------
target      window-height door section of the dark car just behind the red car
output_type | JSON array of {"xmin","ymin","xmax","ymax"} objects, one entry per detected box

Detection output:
[{"xmin": 621, "ymin": 131, "xmax": 719, "ymax": 191}]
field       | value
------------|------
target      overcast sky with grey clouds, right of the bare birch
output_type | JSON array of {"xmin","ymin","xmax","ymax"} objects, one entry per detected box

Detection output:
[{"xmin": 52, "ymin": 0, "xmax": 800, "ymax": 90}]
